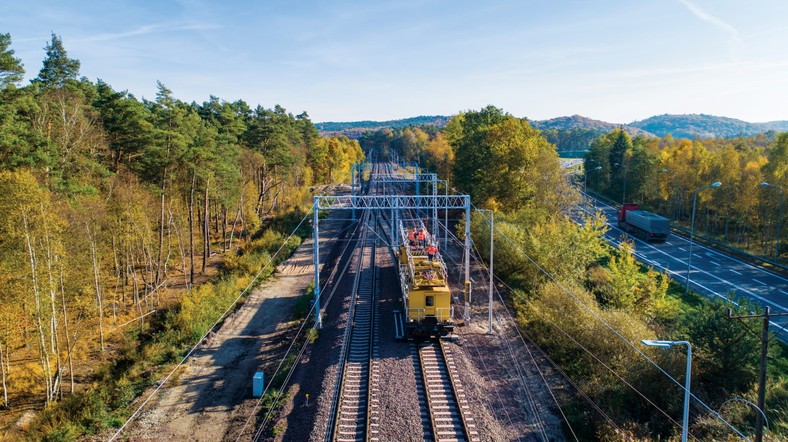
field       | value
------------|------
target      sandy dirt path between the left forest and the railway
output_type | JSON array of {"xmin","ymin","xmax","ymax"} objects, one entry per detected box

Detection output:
[{"xmin": 129, "ymin": 195, "xmax": 346, "ymax": 441}]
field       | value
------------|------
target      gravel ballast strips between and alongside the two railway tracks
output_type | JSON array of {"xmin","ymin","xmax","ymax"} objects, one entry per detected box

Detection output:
[{"xmin": 269, "ymin": 212, "xmax": 564, "ymax": 441}]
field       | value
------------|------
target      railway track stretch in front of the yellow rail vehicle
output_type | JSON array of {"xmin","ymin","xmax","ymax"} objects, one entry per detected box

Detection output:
[{"xmin": 413, "ymin": 340, "xmax": 481, "ymax": 442}]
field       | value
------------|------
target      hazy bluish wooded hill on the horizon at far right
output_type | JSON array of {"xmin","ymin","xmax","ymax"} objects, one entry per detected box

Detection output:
[{"xmin": 629, "ymin": 114, "xmax": 788, "ymax": 138}]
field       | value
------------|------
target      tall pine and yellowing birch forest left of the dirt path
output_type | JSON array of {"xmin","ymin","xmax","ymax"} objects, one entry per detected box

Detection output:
[{"xmin": 0, "ymin": 33, "xmax": 363, "ymax": 440}]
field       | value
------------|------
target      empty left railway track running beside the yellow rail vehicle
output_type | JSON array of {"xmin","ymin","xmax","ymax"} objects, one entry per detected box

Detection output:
[{"xmin": 326, "ymin": 212, "xmax": 381, "ymax": 441}]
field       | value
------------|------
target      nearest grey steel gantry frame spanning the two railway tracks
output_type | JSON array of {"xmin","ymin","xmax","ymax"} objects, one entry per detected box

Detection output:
[{"xmin": 312, "ymin": 195, "xmax": 471, "ymax": 329}]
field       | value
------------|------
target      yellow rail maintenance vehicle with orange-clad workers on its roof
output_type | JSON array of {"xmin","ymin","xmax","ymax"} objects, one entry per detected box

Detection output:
[{"xmin": 399, "ymin": 227, "xmax": 454, "ymax": 339}]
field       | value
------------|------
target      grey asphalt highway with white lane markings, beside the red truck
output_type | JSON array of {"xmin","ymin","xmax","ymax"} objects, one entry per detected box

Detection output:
[{"xmin": 587, "ymin": 196, "xmax": 788, "ymax": 343}]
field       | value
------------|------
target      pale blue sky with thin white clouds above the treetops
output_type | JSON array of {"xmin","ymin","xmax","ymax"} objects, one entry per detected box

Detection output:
[{"xmin": 0, "ymin": 0, "xmax": 788, "ymax": 123}]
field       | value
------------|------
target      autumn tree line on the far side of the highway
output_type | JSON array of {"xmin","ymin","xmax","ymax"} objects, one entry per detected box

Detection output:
[{"xmin": 585, "ymin": 130, "xmax": 788, "ymax": 258}]
